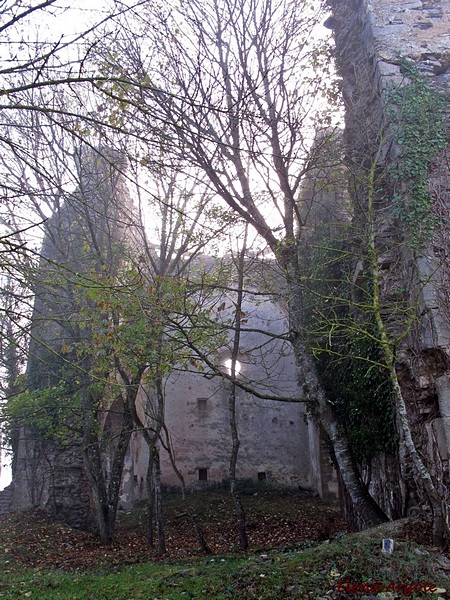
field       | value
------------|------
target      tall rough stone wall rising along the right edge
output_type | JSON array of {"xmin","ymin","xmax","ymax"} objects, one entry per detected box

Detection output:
[{"xmin": 327, "ymin": 0, "xmax": 450, "ymax": 517}]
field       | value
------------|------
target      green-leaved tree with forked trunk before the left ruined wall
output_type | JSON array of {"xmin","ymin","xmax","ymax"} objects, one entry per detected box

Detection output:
[{"xmin": 1, "ymin": 143, "xmax": 142, "ymax": 543}]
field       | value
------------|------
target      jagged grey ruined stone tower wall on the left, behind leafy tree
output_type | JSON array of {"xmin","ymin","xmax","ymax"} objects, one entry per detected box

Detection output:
[{"xmin": 11, "ymin": 149, "xmax": 138, "ymax": 528}]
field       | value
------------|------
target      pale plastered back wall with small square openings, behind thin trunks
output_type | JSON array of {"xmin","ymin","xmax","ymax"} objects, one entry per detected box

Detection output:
[{"xmin": 121, "ymin": 293, "xmax": 320, "ymax": 507}]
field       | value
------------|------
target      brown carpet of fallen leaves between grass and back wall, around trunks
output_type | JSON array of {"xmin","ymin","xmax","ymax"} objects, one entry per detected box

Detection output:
[{"xmin": 0, "ymin": 490, "xmax": 347, "ymax": 570}]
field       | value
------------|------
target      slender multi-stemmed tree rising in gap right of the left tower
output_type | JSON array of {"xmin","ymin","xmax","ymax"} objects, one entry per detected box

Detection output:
[{"xmin": 120, "ymin": 167, "xmax": 225, "ymax": 554}]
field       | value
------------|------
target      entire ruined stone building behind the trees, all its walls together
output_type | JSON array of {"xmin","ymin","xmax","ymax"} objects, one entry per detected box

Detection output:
[{"xmin": 0, "ymin": 0, "xmax": 450, "ymax": 536}]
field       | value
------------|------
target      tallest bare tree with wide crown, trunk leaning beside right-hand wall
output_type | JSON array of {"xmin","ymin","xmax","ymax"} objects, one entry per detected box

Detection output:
[{"xmin": 98, "ymin": 0, "xmax": 386, "ymax": 523}]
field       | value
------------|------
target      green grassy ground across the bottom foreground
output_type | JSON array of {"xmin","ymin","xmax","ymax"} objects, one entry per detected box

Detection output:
[{"xmin": 0, "ymin": 494, "xmax": 450, "ymax": 600}]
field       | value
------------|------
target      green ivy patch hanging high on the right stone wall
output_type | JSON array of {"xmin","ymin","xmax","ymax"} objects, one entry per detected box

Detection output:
[{"xmin": 387, "ymin": 60, "xmax": 447, "ymax": 248}]
